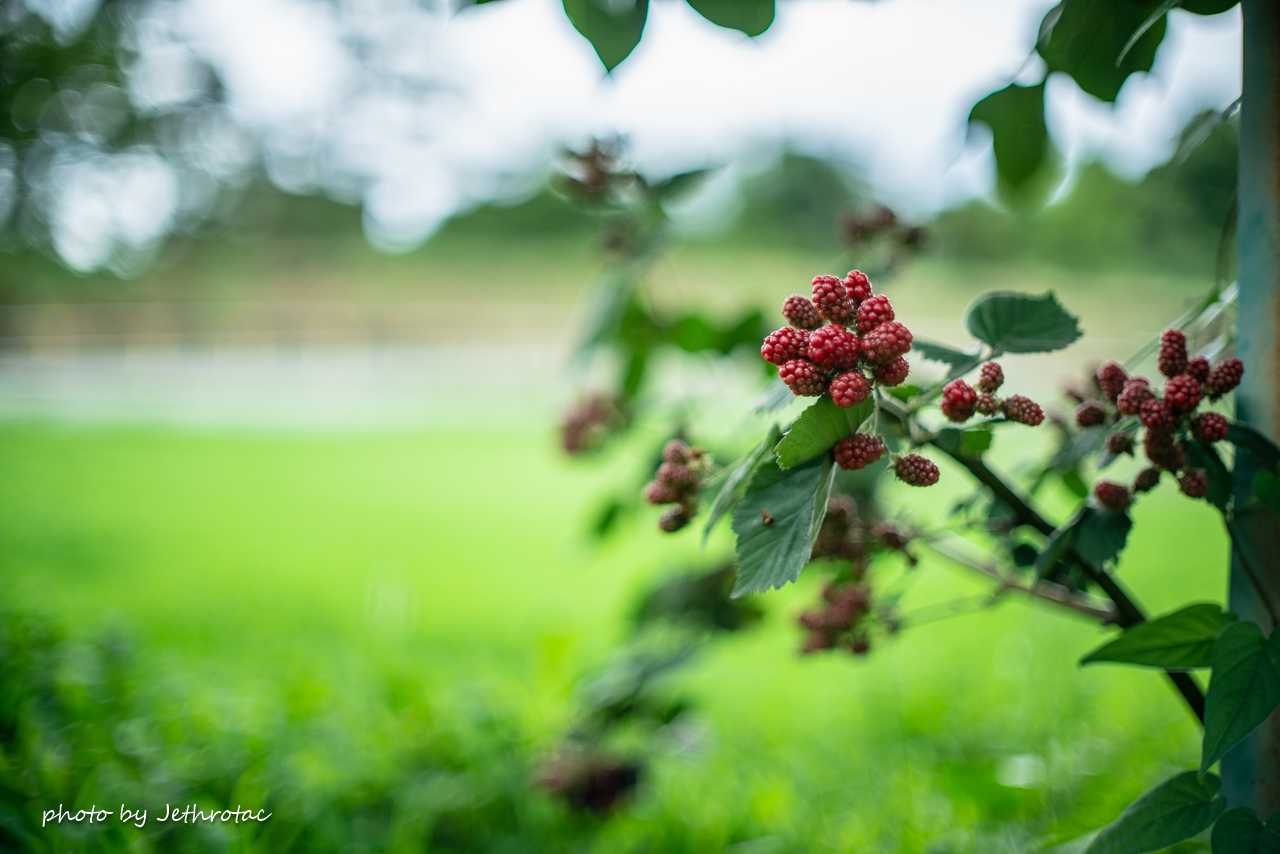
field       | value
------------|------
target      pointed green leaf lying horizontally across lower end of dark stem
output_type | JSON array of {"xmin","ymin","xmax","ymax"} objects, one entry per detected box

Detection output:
[{"xmin": 1080, "ymin": 603, "xmax": 1235, "ymax": 670}]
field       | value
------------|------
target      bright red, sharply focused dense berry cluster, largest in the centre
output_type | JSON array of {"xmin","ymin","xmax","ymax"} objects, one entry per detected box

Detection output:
[{"xmin": 760, "ymin": 270, "xmax": 911, "ymax": 407}]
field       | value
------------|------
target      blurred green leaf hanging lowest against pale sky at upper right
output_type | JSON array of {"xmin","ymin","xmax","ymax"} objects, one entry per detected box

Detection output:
[{"xmin": 969, "ymin": 83, "xmax": 1053, "ymax": 197}]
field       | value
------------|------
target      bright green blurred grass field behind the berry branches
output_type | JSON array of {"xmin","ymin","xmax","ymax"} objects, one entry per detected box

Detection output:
[{"xmin": 0, "ymin": 423, "xmax": 1225, "ymax": 851}]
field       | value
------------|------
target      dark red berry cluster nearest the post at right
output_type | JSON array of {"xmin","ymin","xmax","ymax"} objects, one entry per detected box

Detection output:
[{"xmin": 1075, "ymin": 329, "xmax": 1244, "ymax": 512}]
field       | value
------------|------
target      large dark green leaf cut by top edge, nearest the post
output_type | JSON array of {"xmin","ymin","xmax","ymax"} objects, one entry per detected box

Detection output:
[{"xmin": 1037, "ymin": 0, "xmax": 1166, "ymax": 101}]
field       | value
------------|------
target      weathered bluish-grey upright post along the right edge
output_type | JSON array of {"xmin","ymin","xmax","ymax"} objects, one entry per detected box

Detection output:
[{"xmin": 1222, "ymin": 0, "xmax": 1280, "ymax": 819}]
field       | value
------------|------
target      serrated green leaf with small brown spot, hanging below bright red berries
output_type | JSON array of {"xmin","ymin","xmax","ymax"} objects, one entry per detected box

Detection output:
[{"xmin": 733, "ymin": 457, "xmax": 836, "ymax": 597}]
